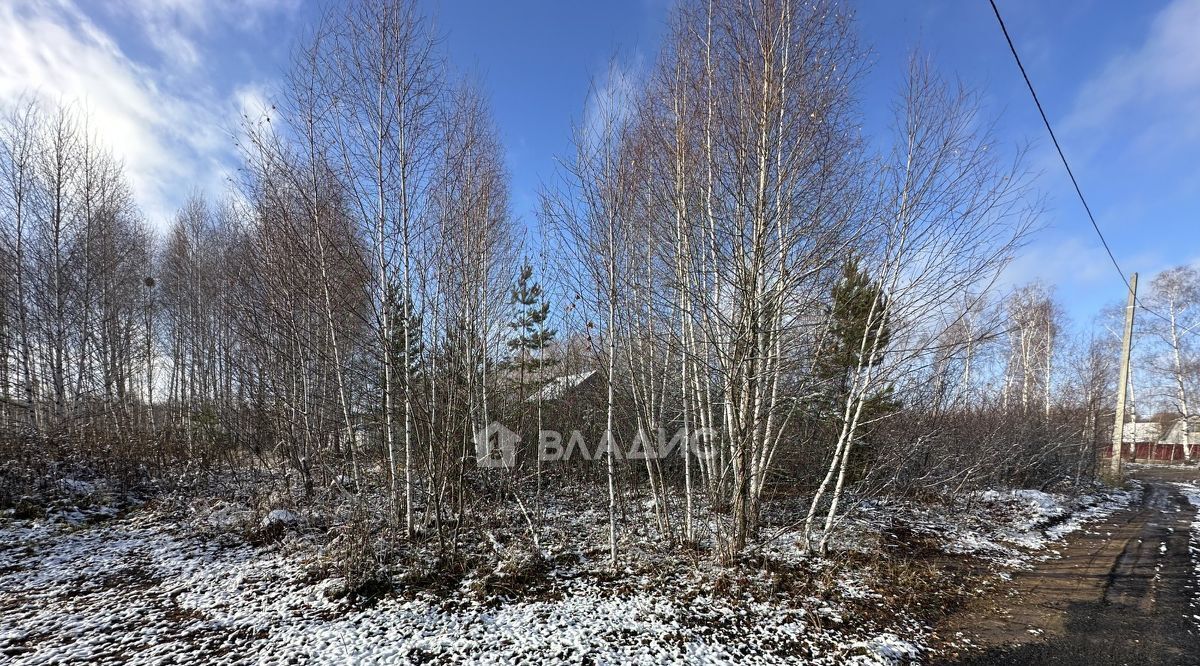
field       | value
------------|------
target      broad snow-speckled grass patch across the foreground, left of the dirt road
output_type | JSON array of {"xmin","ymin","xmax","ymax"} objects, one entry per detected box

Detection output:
[{"xmin": 0, "ymin": 509, "xmax": 920, "ymax": 666}]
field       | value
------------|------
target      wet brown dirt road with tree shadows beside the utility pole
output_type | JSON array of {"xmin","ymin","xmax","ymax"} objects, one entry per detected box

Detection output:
[{"xmin": 936, "ymin": 468, "xmax": 1200, "ymax": 666}]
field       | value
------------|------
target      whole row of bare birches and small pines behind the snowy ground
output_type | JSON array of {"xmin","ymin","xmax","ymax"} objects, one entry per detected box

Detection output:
[{"xmin": 0, "ymin": 0, "xmax": 1142, "ymax": 559}]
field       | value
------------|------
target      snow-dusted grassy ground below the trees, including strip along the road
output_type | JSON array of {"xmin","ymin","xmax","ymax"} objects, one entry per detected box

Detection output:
[{"xmin": 0, "ymin": 491, "xmax": 1132, "ymax": 665}]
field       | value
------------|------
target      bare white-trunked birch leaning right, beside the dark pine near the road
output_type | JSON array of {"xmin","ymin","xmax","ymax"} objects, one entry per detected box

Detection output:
[{"xmin": 805, "ymin": 58, "xmax": 1033, "ymax": 551}]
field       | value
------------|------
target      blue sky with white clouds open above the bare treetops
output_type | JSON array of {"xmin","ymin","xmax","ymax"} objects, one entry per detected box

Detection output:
[{"xmin": 0, "ymin": 0, "xmax": 1200, "ymax": 323}]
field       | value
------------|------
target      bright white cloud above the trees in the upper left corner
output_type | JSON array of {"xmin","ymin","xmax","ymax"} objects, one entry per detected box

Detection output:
[{"xmin": 0, "ymin": 0, "xmax": 288, "ymax": 224}]
